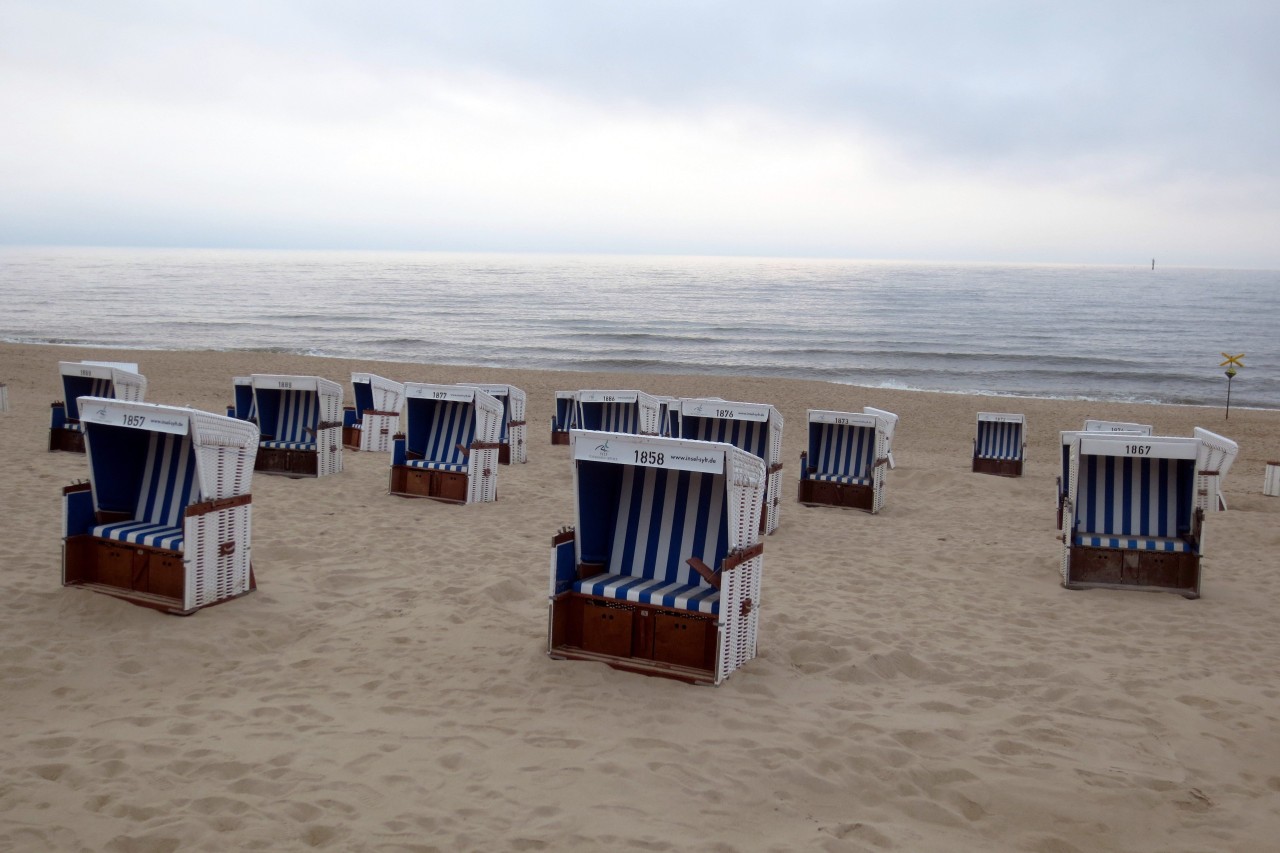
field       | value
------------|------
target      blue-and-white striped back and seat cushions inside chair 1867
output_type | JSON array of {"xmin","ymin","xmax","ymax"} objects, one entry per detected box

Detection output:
[{"xmin": 1073, "ymin": 456, "xmax": 1193, "ymax": 551}]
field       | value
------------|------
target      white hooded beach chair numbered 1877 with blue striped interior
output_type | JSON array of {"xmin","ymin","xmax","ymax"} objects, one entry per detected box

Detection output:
[{"xmin": 388, "ymin": 382, "xmax": 502, "ymax": 503}]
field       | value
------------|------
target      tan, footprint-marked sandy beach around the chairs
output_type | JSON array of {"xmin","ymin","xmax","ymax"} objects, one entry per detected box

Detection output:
[{"xmin": 0, "ymin": 345, "xmax": 1280, "ymax": 853}]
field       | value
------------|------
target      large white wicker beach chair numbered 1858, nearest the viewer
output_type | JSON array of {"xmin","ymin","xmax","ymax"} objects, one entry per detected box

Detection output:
[{"xmin": 547, "ymin": 430, "xmax": 765, "ymax": 684}]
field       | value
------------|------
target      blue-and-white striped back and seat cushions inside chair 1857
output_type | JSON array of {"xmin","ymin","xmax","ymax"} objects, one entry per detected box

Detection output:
[{"xmin": 91, "ymin": 433, "xmax": 200, "ymax": 551}]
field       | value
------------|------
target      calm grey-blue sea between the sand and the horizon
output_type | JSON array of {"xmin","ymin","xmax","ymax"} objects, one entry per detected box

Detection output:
[{"xmin": 0, "ymin": 248, "xmax": 1280, "ymax": 409}]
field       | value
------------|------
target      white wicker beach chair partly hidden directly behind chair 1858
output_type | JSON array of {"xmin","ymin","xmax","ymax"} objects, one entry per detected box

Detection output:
[{"xmin": 677, "ymin": 398, "xmax": 782, "ymax": 534}]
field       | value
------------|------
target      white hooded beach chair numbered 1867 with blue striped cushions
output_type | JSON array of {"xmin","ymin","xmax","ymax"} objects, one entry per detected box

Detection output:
[{"xmin": 1062, "ymin": 429, "xmax": 1238, "ymax": 598}]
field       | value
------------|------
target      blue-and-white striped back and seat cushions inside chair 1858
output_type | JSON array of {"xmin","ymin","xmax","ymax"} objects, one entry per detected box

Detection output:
[{"xmin": 573, "ymin": 466, "xmax": 728, "ymax": 613}]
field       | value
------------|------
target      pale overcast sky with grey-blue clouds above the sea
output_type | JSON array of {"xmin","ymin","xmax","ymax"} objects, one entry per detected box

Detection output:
[{"xmin": 0, "ymin": 0, "xmax": 1280, "ymax": 268}]
